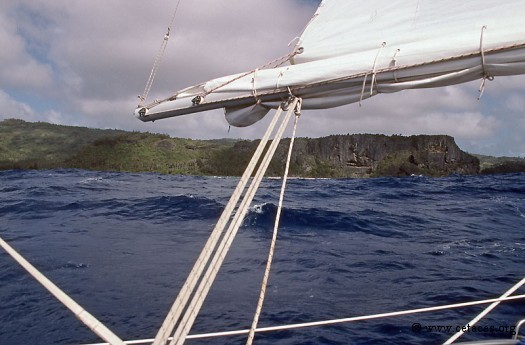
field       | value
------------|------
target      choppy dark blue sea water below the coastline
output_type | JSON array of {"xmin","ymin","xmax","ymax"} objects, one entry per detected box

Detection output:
[{"xmin": 0, "ymin": 170, "xmax": 525, "ymax": 345}]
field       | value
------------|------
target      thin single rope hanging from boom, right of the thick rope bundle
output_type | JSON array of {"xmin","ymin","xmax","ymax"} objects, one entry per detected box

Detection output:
[{"xmin": 246, "ymin": 99, "xmax": 302, "ymax": 345}]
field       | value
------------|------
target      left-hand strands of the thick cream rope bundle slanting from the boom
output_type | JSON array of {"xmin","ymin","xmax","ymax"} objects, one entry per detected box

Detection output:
[{"xmin": 154, "ymin": 104, "xmax": 282, "ymax": 345}]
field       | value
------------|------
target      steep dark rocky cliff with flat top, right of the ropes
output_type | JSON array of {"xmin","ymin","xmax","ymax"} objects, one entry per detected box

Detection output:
[{"xmin": 266, "ymin": 134, "xmax": 479, "ymax": 177}]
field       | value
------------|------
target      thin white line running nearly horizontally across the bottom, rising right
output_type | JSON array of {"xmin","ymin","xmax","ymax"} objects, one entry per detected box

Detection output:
[{"xmin": 85, "ymin": 295, "xmax": 525, "ymax": 345}]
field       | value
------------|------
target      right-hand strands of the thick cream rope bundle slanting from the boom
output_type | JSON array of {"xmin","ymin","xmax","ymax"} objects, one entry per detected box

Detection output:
[{"xmin": 170, "ymin": 98, "xmax": 298, "ymax": 345}]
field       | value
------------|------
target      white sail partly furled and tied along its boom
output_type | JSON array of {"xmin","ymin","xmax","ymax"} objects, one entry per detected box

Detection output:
[{"xmin": 136, "ymin": 0, "xmax": 525, "ymax": 126}]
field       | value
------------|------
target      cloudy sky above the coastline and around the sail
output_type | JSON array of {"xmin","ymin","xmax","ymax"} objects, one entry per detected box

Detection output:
[{"xmin": 0, "ymin": 0, "xmax": 525, "ymax": 156}]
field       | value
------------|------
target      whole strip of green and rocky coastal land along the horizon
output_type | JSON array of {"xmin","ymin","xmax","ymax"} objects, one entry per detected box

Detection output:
[{"xmin": 0, "ymin": 119, "xmax": 525, "ymax": 178}]
